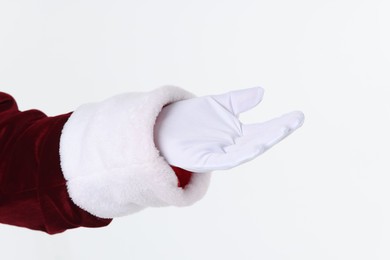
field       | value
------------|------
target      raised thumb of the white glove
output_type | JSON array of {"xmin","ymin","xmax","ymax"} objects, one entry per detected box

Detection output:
[{"xmin": 210, "ymin": 87, "xmax": 264, "ymax": 115}]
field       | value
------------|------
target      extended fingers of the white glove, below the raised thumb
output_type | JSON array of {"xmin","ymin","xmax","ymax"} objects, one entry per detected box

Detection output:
[{"xmin": 241, "ymin": 111, "xmax": 304, "ymax": 149}]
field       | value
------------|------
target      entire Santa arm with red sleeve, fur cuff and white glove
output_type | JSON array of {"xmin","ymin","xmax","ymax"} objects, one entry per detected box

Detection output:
[{"xmin": 0, "ymin": 86, "xmax": 304, "ymax": 234}]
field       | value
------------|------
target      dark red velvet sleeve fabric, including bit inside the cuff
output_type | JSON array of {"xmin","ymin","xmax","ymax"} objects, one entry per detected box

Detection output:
[{"xmin": 0, "ymin": 92, "xmax": 192, "ymax": 234}]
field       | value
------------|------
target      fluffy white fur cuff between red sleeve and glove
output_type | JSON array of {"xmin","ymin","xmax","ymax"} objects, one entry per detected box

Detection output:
[{"xmin": 60, "ymin": 86, "xmax": 210, "ymax": 218}]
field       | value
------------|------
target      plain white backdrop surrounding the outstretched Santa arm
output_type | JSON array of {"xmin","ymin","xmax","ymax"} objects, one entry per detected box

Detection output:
[{"xmin": 0, "ymin": 0, "xmax": 390, "ymax": 260}]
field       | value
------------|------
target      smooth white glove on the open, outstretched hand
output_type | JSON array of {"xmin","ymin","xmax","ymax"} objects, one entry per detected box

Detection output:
[{"xmin": 154, "ymin": 87, "xmax": 304, "ymax": 172}]
